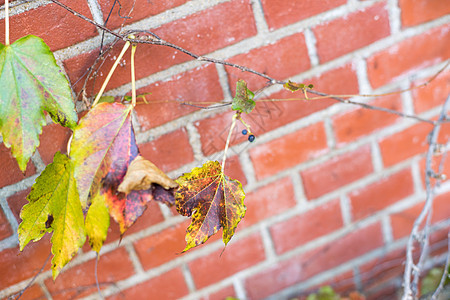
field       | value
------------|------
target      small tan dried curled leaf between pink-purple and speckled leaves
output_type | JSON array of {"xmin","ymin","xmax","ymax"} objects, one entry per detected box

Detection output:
[{"xmin": 117, "ymin": 155, "xmax": 178, "ymax": 194}]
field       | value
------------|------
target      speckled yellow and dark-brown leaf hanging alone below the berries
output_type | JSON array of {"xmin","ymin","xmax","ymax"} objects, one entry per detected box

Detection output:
[{"xmin": 175, "ymin": 161, "xmax": 246, "ymax": 252}]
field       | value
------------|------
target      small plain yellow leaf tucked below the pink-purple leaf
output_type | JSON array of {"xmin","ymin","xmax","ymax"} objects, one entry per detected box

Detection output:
[{"xmin": 86, "ymin": 194, "xmax": 109, "ymax": 253}]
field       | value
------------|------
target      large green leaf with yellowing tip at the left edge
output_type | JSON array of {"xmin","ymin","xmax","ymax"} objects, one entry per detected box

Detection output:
[{"xmin": 0, "ymin": 35, "xmax": 77, "ymax": 171}]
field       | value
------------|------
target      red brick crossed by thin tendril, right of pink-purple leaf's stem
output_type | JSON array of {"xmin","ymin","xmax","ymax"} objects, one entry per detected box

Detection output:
[{"xmin": 136, "ymin": 64, "xmax": 223, "ymax": 131}]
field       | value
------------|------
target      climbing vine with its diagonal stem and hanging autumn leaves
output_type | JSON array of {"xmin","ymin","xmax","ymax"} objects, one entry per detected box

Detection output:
[{"xmin": 0, "ymin": 0, "xmax": 449, "ymax": 298}]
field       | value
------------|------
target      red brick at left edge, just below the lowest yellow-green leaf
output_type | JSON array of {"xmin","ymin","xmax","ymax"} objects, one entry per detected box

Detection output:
[{"xmin": 0, "ymin": 235, "xmax": 50, "ymax": 290}]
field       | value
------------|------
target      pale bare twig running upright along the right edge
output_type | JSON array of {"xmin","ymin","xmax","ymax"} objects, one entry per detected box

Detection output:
[{"xmin": 402, "ymin": 95, "xmax": 450, "ymax": 300}]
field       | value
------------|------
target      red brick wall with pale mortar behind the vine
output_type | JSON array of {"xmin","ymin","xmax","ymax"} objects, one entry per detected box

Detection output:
[{"xmin": 0, "ymin": 0, "xmax": 450, "ymax": 299}]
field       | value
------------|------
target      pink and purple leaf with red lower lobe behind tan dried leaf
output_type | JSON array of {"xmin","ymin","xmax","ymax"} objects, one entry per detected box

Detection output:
[{"xmin": 70, "ymin": 103, "xmax": 163, "ymax": 234}]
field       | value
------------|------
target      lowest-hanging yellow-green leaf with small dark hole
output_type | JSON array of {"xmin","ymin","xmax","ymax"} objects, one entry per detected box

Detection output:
[{"xmin": 18, "ymin": 152, "xmax": 86, "ymax": 278}]
